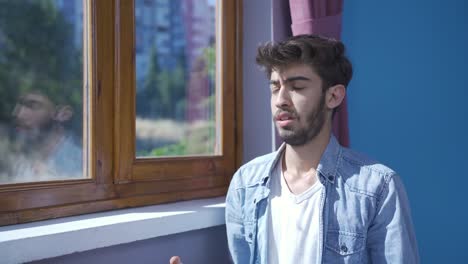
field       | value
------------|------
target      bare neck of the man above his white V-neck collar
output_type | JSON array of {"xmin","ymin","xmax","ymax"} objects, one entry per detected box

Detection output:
[{"xmin": 283, "ymin": 119, "xmax": 331, "ymax": 177}]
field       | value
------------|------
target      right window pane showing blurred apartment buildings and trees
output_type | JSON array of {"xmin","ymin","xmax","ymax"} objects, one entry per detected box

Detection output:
[{"xmin": 135, "ymin": 0, "xmax": 220, "ymax": 157}]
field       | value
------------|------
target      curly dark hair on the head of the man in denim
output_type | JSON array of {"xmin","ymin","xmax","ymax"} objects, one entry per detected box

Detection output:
[{"xmin": 256, "ymin": 35, "xmax": 353, "ymax": 90}]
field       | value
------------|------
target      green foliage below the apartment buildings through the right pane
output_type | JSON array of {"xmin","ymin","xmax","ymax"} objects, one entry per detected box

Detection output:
[{"xmin": 136, "ymin": 41, "xmax": 216, "ymax": 157}]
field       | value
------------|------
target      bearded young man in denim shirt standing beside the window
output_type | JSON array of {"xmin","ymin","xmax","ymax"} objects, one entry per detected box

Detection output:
[{"xmin": 226, "ymin": 35, "xmax": 419, "ymax": 264}]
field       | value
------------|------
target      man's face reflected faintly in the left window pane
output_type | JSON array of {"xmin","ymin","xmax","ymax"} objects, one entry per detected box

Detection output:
[{"xmin": 12, "ymin": 93, "xmax": 55, "ymax": 143}]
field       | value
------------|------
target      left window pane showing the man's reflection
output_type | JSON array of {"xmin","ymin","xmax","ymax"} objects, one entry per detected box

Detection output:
[{"xmin": 0, "ymin": 0, "xmax": 83, "ymax": 184}]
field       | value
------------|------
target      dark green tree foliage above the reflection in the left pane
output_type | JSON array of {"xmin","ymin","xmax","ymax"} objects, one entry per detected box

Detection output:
[{"xmin": 0, "ymin": 0, "xmax": 83, "ymax": 131}]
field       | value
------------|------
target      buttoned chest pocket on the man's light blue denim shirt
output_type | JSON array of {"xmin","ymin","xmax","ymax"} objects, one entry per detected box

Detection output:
[{"xmin": 325, "ymin": 231, "xmax": 366, "ymax": 257}]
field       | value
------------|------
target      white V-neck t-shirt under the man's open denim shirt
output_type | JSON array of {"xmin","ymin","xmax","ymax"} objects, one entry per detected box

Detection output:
[{"xmin": 267, "ymin": 161, "xmax": 323, "ymax": 264}]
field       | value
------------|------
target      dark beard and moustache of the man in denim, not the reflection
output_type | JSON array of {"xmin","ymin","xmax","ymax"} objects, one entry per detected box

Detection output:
[{"xmin": 275, "ymin": 93, "xmax": 326, "ymax": 146}]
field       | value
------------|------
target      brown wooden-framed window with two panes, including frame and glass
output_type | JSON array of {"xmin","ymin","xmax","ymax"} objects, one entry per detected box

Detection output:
[{"xmin": 0, "ymin": 0, "xmax": 241, "ymax": 225}]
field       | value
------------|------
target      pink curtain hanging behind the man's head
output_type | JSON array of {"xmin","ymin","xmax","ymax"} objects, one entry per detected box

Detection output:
[{"xmin": 289, "ymin": 0, "xmax": 349, "ymax": 147}]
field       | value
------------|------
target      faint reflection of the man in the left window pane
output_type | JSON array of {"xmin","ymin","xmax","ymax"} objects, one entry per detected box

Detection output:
[{"xmin": 2, "ymin": 88, "xmax": 83, "ymax": 183}]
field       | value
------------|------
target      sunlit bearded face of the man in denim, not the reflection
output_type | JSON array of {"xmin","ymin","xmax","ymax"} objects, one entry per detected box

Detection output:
[{"xmin": 270, "ymin": 64, "xmax": 327, "ymax": 146}]
